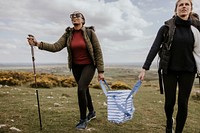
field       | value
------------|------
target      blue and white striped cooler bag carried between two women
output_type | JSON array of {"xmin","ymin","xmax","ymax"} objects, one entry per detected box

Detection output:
[{"xmin": 100, "ymin": 80, "xmax": 142, "ymax": 124}]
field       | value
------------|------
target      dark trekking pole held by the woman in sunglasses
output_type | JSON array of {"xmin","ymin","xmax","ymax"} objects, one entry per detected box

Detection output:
[{"xmin": 28, "ymin": 35, "xmax": 42, "ymax": 130}]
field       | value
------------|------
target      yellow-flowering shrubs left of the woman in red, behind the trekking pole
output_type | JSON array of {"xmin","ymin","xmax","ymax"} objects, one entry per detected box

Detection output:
[{"xmin": 0, "ymin": 71, "xmax": 77, "ymax": 88}]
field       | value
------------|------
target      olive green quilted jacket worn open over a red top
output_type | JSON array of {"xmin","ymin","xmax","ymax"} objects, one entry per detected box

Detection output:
[{"xmin": 38, "ymin": 26, "xmax": 104, "ymax": 72}]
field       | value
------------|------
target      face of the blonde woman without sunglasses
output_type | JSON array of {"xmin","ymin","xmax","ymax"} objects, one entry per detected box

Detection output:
[{"xmin": 176, "ymin": 0, "xmax": 192, "ymax": 19}]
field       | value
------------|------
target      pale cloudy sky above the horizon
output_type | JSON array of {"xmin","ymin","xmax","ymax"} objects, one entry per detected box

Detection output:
[{"xmin": 0, "ymin": 0, "xmax": 200, "ymax": 63}]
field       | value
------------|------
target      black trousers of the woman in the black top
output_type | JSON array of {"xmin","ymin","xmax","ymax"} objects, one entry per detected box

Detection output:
[{"xmin": 163, "ymin": 71, "xmax": 195, "ymax": 133}]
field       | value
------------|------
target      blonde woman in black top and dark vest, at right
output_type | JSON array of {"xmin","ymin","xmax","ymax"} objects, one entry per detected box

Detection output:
[{"xmin": 139, "ymin": 0, "xmax": 200, "ymax": 133}]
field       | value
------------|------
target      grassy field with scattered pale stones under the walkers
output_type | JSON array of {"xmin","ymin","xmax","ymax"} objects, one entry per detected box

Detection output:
[{"xmin": 0, "ymin": 66, "xmax": 200, "ymax": 133}]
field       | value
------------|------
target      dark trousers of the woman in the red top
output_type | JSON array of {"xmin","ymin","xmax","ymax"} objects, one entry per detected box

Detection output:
[{"xmin": 72, "ymin": 64, "xmax": 95, "ymax": 120}]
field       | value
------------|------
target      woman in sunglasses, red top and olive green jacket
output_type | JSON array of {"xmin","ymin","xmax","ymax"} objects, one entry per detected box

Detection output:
[{"xmin": 27, "ymin": 11, "xmax": 104, "ymax": 129}]
